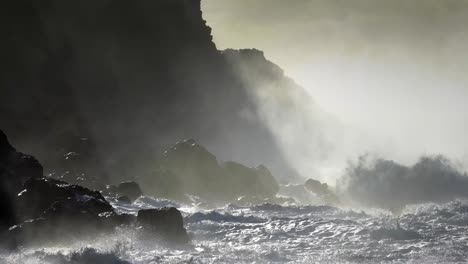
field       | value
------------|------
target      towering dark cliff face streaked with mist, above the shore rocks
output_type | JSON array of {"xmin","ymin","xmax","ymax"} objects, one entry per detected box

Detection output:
[{"xmin": 0, "ymin": 0, "xmax": 296, "ymax": 184}]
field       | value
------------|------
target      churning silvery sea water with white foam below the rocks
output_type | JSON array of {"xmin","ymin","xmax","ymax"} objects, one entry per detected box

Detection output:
[{"xmin": 0, "ymin": 197, "xmax": 468, "ymax": 264}]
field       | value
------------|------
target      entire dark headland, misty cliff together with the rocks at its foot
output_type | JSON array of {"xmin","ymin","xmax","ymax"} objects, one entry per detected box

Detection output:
[{"xmin": 0, "ymin": 0, "xmax": 308, "ymax": 248}]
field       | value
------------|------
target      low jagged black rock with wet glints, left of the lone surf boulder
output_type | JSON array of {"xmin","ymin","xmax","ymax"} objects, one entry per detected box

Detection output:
[{"xmin": 9, "ymin": 178, "xmax": 134, "ymax": 244}]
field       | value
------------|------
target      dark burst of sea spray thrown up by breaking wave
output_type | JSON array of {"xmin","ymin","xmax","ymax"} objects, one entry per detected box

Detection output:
[{"xmin": 338, "ymin": 155, "xmax": 468, "ymax": 213}]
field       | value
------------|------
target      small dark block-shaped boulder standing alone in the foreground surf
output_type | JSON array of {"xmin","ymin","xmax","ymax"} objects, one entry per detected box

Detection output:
[{"xmin": 137, "ymin": 207, "xmax": 189, "ymax": 244}]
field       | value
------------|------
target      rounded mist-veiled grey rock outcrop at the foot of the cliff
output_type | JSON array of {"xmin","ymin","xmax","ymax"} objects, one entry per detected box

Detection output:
[{"xmin": 139, "ymin": 139, "xmax": 279, "ymax": 202}]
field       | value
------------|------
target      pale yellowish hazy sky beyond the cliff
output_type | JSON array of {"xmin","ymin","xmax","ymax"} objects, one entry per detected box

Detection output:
[{"xmin": 203, "ymin": 0, "xmax": 468, "ymax": 177}]
